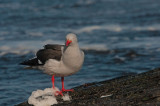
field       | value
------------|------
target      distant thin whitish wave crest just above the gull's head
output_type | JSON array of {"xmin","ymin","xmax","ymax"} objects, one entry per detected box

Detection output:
[{"xmin": 26, "ymin": 24, "xmax": 160, "ymax": 37}]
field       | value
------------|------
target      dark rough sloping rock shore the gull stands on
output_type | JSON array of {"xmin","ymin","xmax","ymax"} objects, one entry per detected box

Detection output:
[{"xmin": 17, "ymin": 68, "xmax": 160, "ymax": 106}]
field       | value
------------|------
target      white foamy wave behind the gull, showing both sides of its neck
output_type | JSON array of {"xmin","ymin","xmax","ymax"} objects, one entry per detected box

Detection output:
[{"xmin": 0, "ymin": 40, "xmax": 107, "ymax": 56}]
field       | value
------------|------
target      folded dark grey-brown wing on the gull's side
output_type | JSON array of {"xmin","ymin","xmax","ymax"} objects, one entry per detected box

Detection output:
[{"xmin": 36, "ymin": 49, "xmax": 62, "ymax": 64}]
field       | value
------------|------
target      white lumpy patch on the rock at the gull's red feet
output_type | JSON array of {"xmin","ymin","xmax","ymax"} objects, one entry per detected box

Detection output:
[{"xmin": 28, "ymin": 87, "xmax": 70, "ymax": 106}]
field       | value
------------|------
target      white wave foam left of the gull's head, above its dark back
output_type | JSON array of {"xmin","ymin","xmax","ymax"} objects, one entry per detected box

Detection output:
[{"xmin": 0, "ymin": 40, "xmax": 63, "ymax": 56}]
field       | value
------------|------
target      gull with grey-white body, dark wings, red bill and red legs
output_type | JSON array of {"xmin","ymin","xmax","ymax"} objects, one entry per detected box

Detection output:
[{"xmin": 20, "ymin": 33, "xmax": 84, "ymax": 95}]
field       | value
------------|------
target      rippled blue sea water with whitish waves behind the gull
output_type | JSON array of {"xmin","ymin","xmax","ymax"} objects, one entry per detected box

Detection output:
[{"xmin": 0, "ymin": 0, "xmax": 160, "ymax": 106}]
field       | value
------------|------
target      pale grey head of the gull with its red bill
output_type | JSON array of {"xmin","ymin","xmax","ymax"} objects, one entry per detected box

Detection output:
[{"xmin": 66, "ymin": 33, "xmax": 77, "ymax": 46}]
